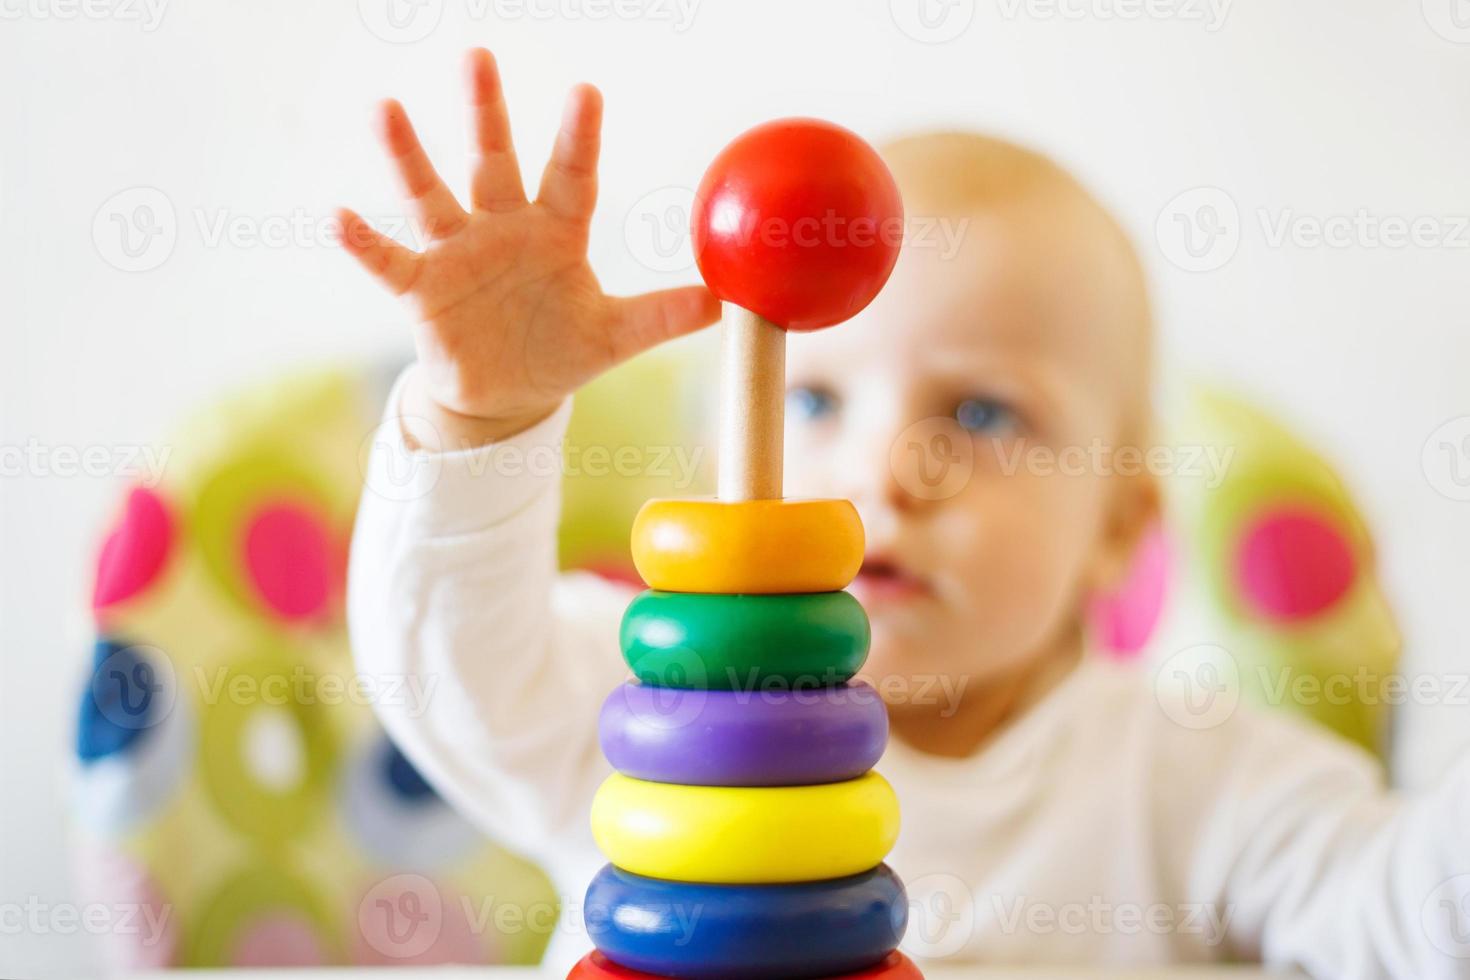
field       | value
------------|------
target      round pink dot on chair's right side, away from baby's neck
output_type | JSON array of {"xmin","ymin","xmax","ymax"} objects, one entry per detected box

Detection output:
[{"xmin": 1235, "ymin": 508, "xmax": 1358, "ymax": 621}]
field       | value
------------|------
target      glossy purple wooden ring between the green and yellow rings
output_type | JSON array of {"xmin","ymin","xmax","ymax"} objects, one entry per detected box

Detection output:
[{"xmin": 597, "ymin": 680, "xmax": 888, "ymax": 786}]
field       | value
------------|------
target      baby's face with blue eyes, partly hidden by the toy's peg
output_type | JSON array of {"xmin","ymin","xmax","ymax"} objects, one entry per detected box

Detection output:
[{"xmin": 786, "ymin": 191, "xmax": 1151, "ymax": 711}]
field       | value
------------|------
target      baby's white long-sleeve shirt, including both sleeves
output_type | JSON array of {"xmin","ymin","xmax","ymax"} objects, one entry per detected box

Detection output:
[{"xmin": 348, "ymin": 370, "xmax": 1470, "ymax": 979}]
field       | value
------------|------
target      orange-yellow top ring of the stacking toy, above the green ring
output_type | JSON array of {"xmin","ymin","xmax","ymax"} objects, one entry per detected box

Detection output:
[{"xmin": 634, "ymin": 498, "xmax": 863, "ymax": 594}]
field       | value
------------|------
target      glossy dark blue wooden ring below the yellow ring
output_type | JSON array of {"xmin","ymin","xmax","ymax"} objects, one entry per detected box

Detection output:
[{"xmin": 584, "ymin": 864, "xmax": 908, "ymax": 980}]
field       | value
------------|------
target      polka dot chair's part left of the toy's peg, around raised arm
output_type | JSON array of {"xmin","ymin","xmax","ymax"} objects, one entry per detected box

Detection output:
[{"xmin": 75, "ymin": 348, "xmax": 717, "ymax": 968}]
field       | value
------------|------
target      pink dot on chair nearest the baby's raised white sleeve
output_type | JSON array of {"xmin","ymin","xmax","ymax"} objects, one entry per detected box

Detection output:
[{"xmin": 244, "ymin": 502, "xmax": 335, "ymax": 620}]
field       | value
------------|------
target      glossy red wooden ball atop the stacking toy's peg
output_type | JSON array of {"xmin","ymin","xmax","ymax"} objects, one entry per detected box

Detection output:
[{"xmin": 691, "ymin": 119, "xmax": 904, "ymax": 331}]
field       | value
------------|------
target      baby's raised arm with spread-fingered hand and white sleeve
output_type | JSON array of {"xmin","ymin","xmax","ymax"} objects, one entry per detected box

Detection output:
[{"xmin": 341, "ymin": 50, "xmax": 719, "ymax": 854}]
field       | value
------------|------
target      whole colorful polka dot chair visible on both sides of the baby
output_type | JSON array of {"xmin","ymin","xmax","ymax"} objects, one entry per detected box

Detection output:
[{"xmin": 75, "ymin": 359, "xmax": 1398, "ymax": 968}]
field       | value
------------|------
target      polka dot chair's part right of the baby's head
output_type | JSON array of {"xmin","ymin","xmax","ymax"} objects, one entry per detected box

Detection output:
[{"xmin": 1094, "ymin": 389, "xmax": 1399, "ymax": 757}]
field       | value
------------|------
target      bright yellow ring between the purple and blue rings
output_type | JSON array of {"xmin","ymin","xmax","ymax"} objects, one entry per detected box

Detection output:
[{"xmin": 592, "ymin": 771, "xmax": 898, "ymax": 884}]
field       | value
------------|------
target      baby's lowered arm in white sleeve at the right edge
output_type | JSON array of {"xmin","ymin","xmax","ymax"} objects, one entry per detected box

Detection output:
[{"xmin": 1180, "ymin": 693, "xmax": 1470, "ymax": 979}]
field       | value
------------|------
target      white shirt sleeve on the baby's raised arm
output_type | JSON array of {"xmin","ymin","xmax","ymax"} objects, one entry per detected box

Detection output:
[{"xmin": 347, "ymin": 367, "xmax": 628, "ymax": 861}]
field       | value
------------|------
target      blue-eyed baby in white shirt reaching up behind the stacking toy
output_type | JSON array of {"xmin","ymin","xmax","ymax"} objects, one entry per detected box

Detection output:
[{"xmin": 341, "ymin": 50, "xmax": 1470, "ymax": 977}]
